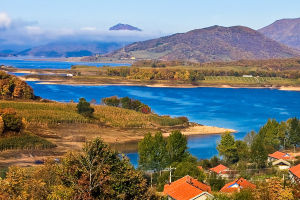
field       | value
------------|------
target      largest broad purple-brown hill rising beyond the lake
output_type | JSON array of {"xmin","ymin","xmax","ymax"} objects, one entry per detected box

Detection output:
[{"xmin": 108, "ymin": 26, "xmax": 300, "ymax": 62}]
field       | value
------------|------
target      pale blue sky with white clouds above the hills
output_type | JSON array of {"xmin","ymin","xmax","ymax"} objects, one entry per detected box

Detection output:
[{"xmin": 0, "ymin": 0, "xmax": 300, "ymax": 46}]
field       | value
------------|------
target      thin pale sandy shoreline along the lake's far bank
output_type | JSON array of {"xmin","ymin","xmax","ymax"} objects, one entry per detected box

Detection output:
[{"xmin": 20, "ymin": 77, "xmax": 300, "ymax": 91}]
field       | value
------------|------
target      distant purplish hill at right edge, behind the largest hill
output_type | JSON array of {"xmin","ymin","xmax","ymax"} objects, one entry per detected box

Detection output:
[{"xmin": 258, "ymin": 18, "xmax": 300, "ymax": 49}]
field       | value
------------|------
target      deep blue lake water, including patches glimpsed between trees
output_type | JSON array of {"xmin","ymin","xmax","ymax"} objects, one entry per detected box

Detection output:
[{"xmin": 0, "ymin": 58, "xmax": 300, "ymax": 166}]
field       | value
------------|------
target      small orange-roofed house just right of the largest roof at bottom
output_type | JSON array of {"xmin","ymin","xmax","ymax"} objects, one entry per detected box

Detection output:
[{"xmin": 220, "ymin": 178, "xmax": 256, "ymax": 193}]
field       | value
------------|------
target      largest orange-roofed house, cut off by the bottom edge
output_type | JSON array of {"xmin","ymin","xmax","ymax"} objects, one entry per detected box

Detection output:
[{"xmin": 164, "ymin": 176, "xmax": 214, "ymax": 200}]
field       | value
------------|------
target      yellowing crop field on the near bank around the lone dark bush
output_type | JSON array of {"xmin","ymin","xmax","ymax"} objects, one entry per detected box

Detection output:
[{"xmin": 0, "ymin": 101, "xmax": 183, "ymax": 128}]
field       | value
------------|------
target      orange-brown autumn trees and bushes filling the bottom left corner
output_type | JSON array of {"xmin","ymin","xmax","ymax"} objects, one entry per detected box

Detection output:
[{"xmin": 0, "ymin": 139, "xmax": 158, "ymax": 200}]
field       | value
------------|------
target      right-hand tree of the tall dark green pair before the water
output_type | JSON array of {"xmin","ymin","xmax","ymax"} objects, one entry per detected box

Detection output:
[{"xmin": 166, "ymin": 131, "xmax": 189, "ymax": 164}]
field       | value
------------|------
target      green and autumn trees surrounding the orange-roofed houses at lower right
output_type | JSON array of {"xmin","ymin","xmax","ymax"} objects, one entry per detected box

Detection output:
[{"xmin": 138, "ymin": 118, "xmax": 300, "ymax": 200}]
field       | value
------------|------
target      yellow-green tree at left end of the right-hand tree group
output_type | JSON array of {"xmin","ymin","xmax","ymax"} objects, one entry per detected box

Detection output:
[{"xmin": 217, "ymin": 133, "xmax": 238, "ymax": 163}]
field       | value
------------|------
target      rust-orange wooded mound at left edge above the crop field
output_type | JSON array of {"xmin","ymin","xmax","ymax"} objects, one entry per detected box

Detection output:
[{"xmin": 0, "ymin": 70, "xmax": 36, "ymax": 99}]
